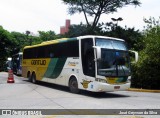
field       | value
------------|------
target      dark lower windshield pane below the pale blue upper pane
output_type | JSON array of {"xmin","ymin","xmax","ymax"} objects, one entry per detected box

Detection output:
[{"xmin": 98, "ymin": 49, "xmax": 130, "ymax": 76}]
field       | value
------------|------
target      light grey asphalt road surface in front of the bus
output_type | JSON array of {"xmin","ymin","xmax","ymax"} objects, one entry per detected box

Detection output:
[{"xmin": 0, "ymin": 72, "xmax": 160, "ymax": 118}]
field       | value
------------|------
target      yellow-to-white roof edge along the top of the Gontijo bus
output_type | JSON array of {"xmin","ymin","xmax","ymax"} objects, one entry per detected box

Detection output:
[{"xmin": 24, "ymin": 35, "xmax": 124, "ymax": 49}]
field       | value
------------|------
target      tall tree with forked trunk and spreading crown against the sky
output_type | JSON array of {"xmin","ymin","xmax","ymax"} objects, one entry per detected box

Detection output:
[{"xmin": 63, "ymin": 0, "xmax": 141, "ymax": 31}]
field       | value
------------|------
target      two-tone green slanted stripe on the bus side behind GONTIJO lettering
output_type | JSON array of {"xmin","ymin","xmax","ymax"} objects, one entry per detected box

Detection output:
[{"xmin": 44, "ymin": 58, "xmax": 67, "ymax": 79}]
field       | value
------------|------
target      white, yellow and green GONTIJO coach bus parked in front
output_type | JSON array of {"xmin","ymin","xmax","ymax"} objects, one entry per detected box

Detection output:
[{"xmin": 22, "ymin": 35, "xmax": 138, "ymax": 93}]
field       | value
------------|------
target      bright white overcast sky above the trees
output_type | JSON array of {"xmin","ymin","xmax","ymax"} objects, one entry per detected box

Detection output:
[{"xmin": 0, "ymin": 0, "xmax": 160, "ymax": 34}]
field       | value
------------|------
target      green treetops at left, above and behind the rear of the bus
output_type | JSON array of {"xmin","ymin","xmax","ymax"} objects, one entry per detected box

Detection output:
[{"xmin": 0, "ymin": 26, "xmax": 61, "ymax": 71}]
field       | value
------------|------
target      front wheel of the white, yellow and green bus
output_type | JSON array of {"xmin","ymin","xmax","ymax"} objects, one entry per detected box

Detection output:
[{"xmin": 69, "ymin": 77, "xmax": 80, "ymax": 93}]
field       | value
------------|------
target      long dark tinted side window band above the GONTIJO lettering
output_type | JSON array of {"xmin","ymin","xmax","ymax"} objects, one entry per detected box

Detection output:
[{"xmin": 23, "ymin": 40, "xmax": 79, "ymax": 59}]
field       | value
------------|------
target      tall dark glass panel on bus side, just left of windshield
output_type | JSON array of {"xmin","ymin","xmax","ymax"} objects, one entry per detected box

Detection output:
[{"xmin": 81, "ymin": 38, "xmax": 95, "ymax": 77}]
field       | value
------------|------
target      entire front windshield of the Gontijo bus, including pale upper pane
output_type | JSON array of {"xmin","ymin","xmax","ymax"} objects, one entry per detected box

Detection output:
[{"xmin": 96, "ymin": 39, "xmax": 130, "ymax": 77}]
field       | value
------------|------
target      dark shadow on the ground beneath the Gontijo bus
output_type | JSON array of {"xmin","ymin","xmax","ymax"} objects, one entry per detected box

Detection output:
[{"xmin": 23, "ymin": 80, "xmax": 130, "ymax": 99}]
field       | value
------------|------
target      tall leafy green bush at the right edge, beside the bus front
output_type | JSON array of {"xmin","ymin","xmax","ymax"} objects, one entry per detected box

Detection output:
[{"xmin": 132, "ymin": 18, "xmax": 160, "ymax": 89}]
